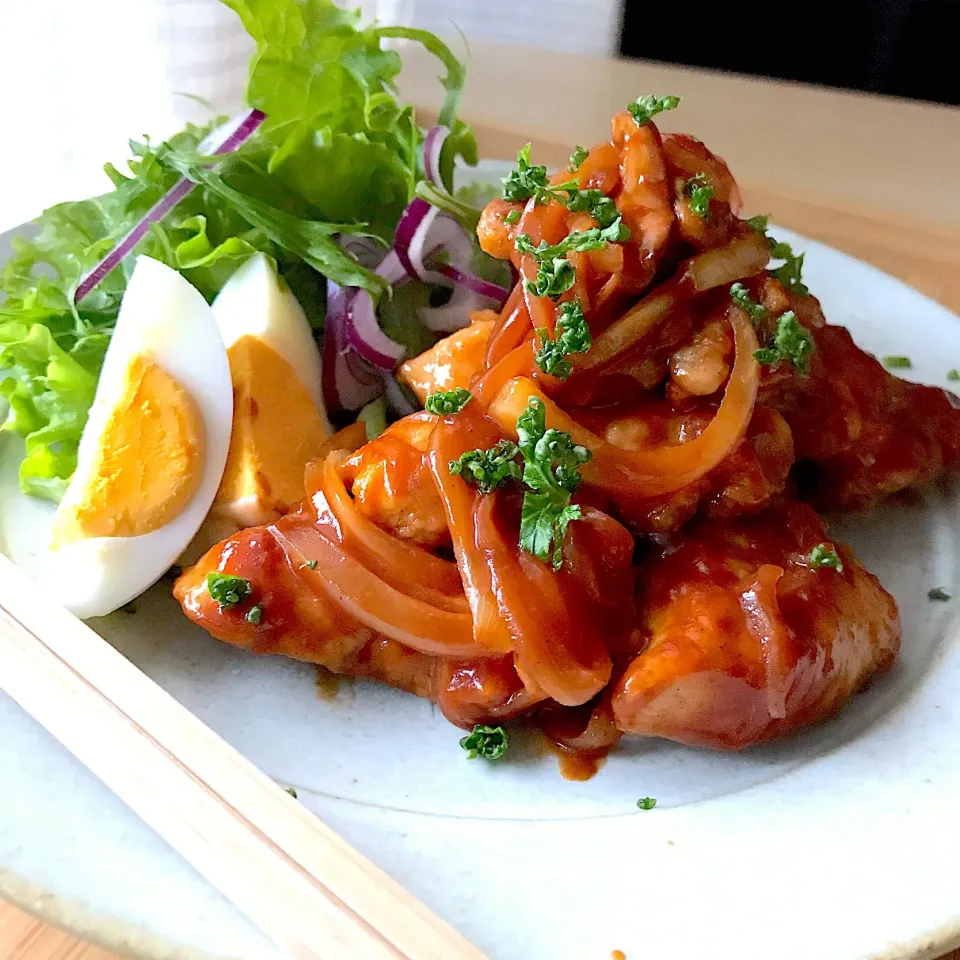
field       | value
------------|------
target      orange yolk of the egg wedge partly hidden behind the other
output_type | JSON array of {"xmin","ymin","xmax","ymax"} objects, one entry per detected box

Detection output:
[{"xmin": 215, "ymin": 335, "xmax": 327, "ymax": 522}]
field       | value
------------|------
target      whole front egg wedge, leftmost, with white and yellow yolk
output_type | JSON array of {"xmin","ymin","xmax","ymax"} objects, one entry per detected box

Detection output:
[{"xmin": 3, "ymin": 257, "xmax": 233, "ymax": 618}]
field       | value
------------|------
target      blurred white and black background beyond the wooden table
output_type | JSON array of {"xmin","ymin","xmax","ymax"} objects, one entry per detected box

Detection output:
[{"xmin": 0, "ymin": 0, "xmax": 960, "ymax": 226}]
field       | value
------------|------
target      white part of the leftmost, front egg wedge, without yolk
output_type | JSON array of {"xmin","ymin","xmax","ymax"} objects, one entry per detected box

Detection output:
[{"xmin": 0, "ymin": 257, "xmax": 233, "ymax": 619}]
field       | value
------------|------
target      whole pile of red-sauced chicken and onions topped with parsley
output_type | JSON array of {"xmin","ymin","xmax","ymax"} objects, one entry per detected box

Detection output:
[{"xmin": 175, "ymin": 101, "xmax": 960, "ymax": 754}]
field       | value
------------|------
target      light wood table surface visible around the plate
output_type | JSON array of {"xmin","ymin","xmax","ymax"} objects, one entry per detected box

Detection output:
[{"xmin": 0, "ymin": 37, "xmax": 960, "ymax": 960}]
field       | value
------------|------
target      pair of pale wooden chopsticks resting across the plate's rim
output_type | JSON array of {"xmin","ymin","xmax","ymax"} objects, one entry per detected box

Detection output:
[{"xmin": 0, "ymin": 557, "xmax": 484, "ymax": 960}]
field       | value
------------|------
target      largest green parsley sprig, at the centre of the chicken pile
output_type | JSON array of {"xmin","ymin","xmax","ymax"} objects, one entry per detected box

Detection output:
[{"xmin": 517, "ymin": 397, "xmax": 591, "ymax": 570}]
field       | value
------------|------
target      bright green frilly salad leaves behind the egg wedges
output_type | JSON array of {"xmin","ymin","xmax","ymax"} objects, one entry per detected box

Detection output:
[{"xmin": 0, "ymin": 0, "xmax": 477, "ymax": 501}]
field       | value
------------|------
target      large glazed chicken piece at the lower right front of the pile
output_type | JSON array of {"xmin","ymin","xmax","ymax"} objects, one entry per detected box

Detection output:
[{"xmin": 612, "ymin": 503, "xmax": 900, "ymax": 749}]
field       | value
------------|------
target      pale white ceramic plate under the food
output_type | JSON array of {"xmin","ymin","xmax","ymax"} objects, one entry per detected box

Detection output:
[{"xmin": 0, "ymin": 164, "xmax": 960, "ymax": 960}]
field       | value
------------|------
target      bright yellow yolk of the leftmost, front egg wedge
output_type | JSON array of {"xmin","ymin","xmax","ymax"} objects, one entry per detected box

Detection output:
[{"xmin": 53, "ymin": 355, "xmax": 204, "ymax": 545}]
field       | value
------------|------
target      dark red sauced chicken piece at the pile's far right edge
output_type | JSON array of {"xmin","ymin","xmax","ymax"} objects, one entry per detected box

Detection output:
[{"xmin": 770, "ymin": 322, "xmax": 960, "ymax": 510}]
